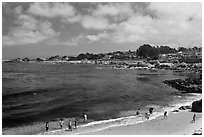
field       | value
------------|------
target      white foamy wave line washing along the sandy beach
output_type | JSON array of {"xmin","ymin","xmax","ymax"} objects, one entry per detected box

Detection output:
[{"xmin": 42, "ymin": 94, "xmax": 202, "ymax": 134}]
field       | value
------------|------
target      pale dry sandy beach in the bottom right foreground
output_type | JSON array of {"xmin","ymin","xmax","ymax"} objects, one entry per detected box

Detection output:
[{"xmin": 39, "ymin": 110, "xmax": 202, "ymax": 135}]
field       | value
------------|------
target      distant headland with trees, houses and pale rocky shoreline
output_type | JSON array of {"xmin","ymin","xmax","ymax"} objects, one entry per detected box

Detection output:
[{"xmin": 3, "ymin": 44, "xmax": 202, "ymax": 73}]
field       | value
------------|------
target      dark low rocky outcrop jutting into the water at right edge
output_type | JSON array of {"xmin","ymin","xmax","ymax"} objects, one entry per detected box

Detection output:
[{"xmin": 163, "ymin": 79, "xmax": 202, "ymax": 93}]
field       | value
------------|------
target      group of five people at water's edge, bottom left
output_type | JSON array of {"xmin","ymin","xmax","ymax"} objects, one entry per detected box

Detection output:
[{"xmin": 45, "ymin": 113, "xmax": 88, "ymax": 132}]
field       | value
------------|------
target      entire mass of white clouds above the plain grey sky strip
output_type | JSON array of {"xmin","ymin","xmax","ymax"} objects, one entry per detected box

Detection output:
[{"xmin": 3, "ymin": 2, "xmax": 202, "ymax": 48}]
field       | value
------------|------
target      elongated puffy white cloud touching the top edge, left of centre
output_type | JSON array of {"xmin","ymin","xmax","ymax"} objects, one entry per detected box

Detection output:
[{"xmin": 28, "ymin": 2, "xmax": 76, "ymax": 18}]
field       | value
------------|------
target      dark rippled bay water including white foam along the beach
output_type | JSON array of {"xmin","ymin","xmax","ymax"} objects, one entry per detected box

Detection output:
[{"xmin": 2, "ymin": 63, "xmax": 201, "ymax": 133}]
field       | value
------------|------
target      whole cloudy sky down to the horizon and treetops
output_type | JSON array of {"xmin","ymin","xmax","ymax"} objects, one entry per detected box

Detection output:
[{"xmin": 2, "ymin": 2, "xmax": 202, "ymax": 59}]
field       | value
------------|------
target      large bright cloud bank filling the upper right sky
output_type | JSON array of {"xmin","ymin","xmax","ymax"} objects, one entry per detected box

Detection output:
[{"xmin": 95, "ymin": 3, "xmax": 202, "ymax": 44}]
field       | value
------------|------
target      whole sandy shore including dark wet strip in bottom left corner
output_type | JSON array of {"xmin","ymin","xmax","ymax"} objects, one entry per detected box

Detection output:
[{"xmin": 2, "ymin": 97, "xmax": 202, "ymax": 135}]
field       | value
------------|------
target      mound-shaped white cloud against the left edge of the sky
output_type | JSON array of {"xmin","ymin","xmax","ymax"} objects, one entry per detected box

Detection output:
[{"xmin": 3, "ymin": 14, "xmax": 57, "ymax": 46}]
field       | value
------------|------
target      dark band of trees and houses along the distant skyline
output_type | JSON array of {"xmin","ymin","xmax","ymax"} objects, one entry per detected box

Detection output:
[{"xmin": 4, "ymin": 44, "xmax": 202, "ymax": 62}]
